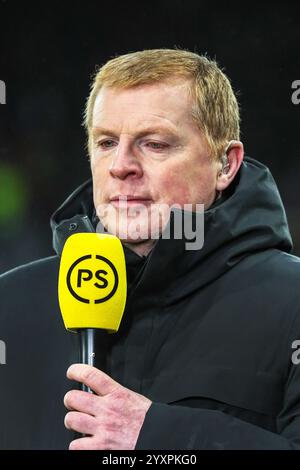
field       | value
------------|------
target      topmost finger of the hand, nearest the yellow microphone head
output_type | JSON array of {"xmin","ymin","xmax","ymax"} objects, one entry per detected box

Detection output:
[{"xmin": 67, "ymin": 364, "xmax": 122, "ymax": 396}]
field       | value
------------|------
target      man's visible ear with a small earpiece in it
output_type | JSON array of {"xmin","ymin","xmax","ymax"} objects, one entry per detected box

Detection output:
[{"xmin": 216, "ymin": 140, "xmax": 244, "ymax": 191}]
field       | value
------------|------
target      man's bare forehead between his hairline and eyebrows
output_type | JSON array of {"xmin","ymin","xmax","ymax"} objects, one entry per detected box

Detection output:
[{"xmin": 93, "ymin": 80, "xmax": 193, "ymax": 127}]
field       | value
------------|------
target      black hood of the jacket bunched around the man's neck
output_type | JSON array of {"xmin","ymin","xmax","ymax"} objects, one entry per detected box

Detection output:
[{"xmin": 50, "ymin": 157, "xmax": 293, "ymax": 300}]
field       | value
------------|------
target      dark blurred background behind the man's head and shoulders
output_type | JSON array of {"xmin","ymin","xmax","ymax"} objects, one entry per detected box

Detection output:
[{"xmin": 0, "ymin": 0, "xmax": 300, "ymax": 272}]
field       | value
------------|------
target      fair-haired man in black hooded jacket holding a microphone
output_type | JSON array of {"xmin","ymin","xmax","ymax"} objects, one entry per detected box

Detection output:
[{"xmin": 0, "ymin": 49, "xmax": 300, "ymax": 449}]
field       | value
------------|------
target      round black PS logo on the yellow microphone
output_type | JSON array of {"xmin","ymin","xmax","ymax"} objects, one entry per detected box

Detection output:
[{"xmin": 67, "ymin": 255, "xmax": 119, "ymax": 304}]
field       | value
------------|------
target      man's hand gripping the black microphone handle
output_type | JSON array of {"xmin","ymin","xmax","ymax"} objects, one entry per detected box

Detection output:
[{"xmin": 64, "ymin": 364, "xmax": 152, "ymax": 450}]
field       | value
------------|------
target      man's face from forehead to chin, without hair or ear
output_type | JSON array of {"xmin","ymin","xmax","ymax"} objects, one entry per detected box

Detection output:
[{"xmin": 91, "ymin": 80, "xmax": 217, "ymax": 250}]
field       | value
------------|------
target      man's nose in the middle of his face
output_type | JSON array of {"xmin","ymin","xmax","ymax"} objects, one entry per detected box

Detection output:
[{"xmin": 109, "ymin": 141, "xmax": 143, "ymax": 180}]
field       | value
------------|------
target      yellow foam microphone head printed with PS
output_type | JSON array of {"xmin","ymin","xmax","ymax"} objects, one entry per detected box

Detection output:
[{"xmin": 58, "ymin": 233, "xmax": 127, "ymax": 332}]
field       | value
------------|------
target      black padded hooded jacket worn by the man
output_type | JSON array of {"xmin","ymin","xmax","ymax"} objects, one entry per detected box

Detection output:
[{"xmin": 0, "ymin": 158, "xmax": 300, "ymax": 449}]
